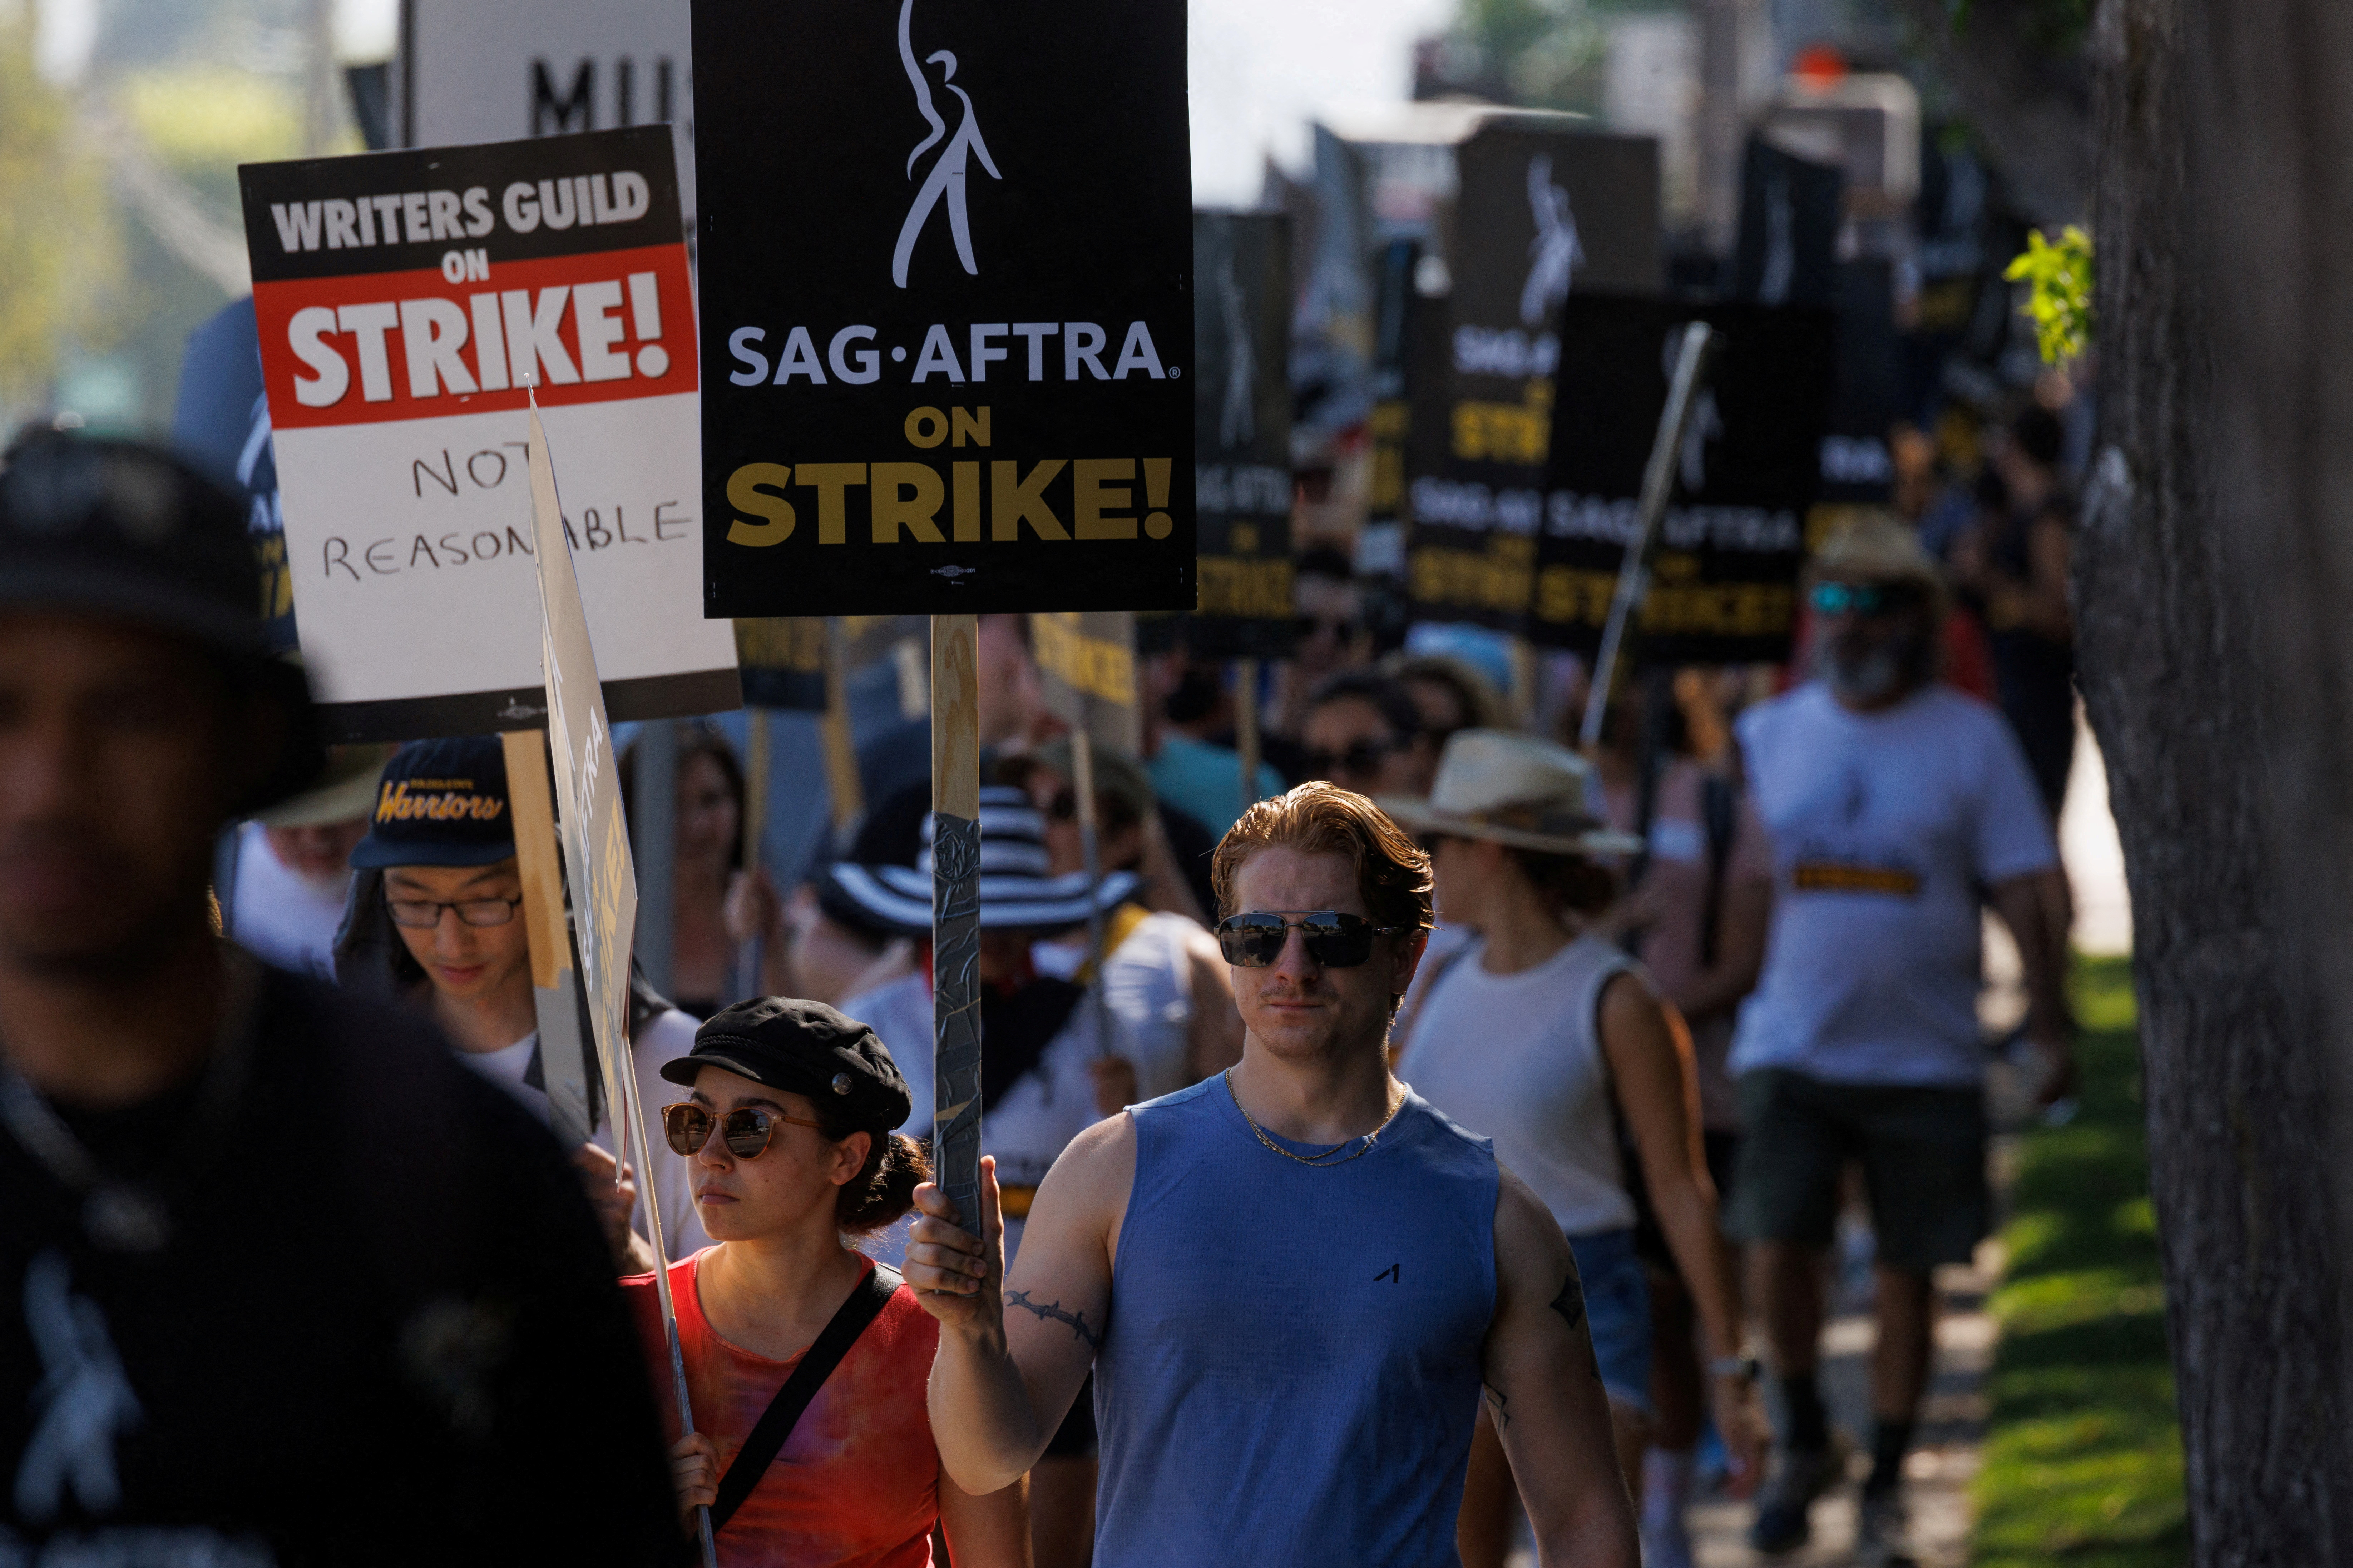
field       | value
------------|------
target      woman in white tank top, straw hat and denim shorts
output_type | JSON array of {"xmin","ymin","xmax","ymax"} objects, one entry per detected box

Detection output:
[{"xmin": 1381, "ymin": 729, "xmax": 1765, "ymax": 1568}]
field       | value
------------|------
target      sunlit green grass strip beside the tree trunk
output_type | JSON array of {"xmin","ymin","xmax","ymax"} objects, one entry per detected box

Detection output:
[{"xmin": 1972, "ymin": 959, "xmax": 2188, "ymax": 1568}]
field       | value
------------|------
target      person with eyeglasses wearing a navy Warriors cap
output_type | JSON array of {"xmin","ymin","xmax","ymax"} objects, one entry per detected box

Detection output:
[{"xmin": 336, "ymin": 736, "xmax": 708, "ymax": 1274}]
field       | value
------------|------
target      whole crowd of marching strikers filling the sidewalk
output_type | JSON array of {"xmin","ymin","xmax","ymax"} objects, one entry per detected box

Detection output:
[{"xmin": 0, "ymin": 421, "xmax": 2071, "ymax": 1568}]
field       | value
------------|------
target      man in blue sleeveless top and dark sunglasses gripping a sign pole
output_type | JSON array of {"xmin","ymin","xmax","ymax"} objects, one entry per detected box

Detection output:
[{"xmin": 906, "ymin": 783, "xmax": 1638, "ymax": 1568}]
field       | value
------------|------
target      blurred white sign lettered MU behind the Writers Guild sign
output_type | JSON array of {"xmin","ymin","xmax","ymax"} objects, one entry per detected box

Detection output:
[{"xmin": 398, "ymin": 0, "xmax": 694, "ymax": 223}]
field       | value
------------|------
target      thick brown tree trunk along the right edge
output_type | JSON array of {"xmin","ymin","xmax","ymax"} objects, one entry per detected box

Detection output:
[{"xmin": 2075, "ymin": 0, "xmax": 2353, "ymax": 1568}]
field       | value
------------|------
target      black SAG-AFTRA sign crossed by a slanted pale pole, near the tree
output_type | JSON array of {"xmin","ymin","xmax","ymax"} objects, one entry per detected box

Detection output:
[{"xmin": 1527, "ymin": 296, "xmax": 1835, "ymax": 663}]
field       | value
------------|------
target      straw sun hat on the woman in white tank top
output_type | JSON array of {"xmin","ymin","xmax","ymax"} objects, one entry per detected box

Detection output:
[{"xmin": 1376, "ymin": 729, "xmax": 1642, "ymax": 856}]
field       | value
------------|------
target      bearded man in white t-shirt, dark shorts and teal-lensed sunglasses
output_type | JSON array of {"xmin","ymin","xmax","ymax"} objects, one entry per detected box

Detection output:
[{"xmin": 1732, "ymin": 517, "xmax": 2073, "ymax": 1563}]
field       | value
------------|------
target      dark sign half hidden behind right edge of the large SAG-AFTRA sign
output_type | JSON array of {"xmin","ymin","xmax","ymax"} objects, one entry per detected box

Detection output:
[{"xmin": 1195, "ymin": 212, "xmax": 1292, "ymax": 663}]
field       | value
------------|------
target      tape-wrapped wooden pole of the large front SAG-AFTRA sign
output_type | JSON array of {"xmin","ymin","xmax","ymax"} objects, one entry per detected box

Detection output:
[{"xmin": 932, "ymin": 616, "xmax": 981, "ymax": 1230}]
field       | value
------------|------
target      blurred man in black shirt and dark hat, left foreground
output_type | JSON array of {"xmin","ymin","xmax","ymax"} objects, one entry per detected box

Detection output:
[{"xmin": 0, "ymin": 435, "xmax": 678, "ymax": 1568}]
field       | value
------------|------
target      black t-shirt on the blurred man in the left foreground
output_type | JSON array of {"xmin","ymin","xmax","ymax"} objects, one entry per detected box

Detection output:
[{"xmin": 0, "ymin": 971, "xmax": 687, "ymax": 1568}]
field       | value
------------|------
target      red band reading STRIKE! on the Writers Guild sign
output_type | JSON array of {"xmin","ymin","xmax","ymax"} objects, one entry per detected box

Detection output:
[{"xmin": 254, "ymin": 244, "xmax": 699, "ymax": 430}]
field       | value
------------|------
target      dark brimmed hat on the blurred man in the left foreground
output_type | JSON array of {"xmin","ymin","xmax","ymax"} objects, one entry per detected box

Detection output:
[{"xmin": 0, "ymin": 432, "xmax": 325, "ymax": 811}]
